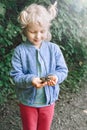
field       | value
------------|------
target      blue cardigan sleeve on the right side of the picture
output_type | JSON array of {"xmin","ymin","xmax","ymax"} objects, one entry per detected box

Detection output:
[{"xmin": 48, "ymin": 45, "xmax": 68, "ymax": 84}]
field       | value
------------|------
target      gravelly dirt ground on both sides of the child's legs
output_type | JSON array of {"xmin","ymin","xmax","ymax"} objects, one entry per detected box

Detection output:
[{"xmin": 0, "ymin": 82, "xmax": 87, "ymax": 130}]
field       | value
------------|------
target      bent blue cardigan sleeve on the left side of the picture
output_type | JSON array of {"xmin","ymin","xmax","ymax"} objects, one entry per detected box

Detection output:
[{"xmin": 10, "ymin": 47, "xmax": 37, "ymax": 88}]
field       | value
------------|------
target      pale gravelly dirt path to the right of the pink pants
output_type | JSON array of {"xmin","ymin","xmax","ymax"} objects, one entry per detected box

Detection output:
[{"xmin": 52, "ymin": 82, "xmax": 87, "ymax": 130}]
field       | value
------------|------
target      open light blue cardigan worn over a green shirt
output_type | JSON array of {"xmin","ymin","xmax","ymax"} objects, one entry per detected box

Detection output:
[{"xmin": 10, "ymin": 41, "xmax": 68, "ymax": 105}]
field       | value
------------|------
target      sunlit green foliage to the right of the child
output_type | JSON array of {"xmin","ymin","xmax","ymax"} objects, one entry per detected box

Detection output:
[{"xmin": 52, "ymin": 0, "xmax": 87, "ymax": 92}]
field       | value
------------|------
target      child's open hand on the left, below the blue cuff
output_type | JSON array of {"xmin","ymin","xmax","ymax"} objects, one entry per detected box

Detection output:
[{"xmin": 32, "ymin": 78, "xmax": 47, "ymax": 88}]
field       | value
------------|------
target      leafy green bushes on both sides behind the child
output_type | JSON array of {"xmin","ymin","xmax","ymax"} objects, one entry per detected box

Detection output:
[{"xmin": 0, "ymin": 0, "xmax": 87, "ymax": 103}]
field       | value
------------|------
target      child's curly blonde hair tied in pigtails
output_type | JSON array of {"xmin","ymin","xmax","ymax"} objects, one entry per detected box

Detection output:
[{"xmin": 18, "ymin": 2, "xmax": 57, "ymax": 41}]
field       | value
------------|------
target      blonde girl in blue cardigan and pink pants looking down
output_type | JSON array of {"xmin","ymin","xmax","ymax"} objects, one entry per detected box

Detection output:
[{"xmin": 10, "ymin": 2, "xmax": 68, "ymax": 130}]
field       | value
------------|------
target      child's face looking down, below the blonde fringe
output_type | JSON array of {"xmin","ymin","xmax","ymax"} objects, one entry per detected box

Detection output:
[{"xmin": 26, "ymin": 23, "xmax": 47, "ymax": 47}]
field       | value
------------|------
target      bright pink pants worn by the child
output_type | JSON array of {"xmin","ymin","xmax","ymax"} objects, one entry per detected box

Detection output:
[{"xmin": 19, "ymin": 104, "xmax": 54, "ymax": 130}]
